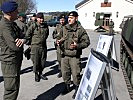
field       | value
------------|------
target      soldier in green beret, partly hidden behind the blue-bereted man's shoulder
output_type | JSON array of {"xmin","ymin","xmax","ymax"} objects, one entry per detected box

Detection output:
[{"xmin": 15, "ymin": 13, "xmax": 27, "ymax": 37}]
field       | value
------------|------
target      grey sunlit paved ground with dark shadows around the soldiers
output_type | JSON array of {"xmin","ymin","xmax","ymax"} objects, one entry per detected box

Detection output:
[{"xmin": 0, "ymin": 28, "xmax": 130, "ymax": 100}]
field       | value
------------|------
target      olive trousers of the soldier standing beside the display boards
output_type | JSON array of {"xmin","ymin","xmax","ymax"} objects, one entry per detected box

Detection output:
[{"xmin": 61, "ymin": 56, "xmax": 81, "ymax": 86}]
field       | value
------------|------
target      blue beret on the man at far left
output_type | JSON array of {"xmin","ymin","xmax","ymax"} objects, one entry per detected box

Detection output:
[{"xmin": 0, "ymin": 1, "xmax": 18, "ymax": 13}]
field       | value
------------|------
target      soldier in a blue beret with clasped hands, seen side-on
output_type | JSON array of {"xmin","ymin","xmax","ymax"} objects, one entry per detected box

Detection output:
[{"xmin": 0, "ymin": 1, "xmax": 23, "ymax": 100}]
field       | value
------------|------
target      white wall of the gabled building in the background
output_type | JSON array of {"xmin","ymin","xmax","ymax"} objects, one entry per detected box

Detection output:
[{"xmin": 77, "ymin": 0, "xmax": 133, "ymax": 31}]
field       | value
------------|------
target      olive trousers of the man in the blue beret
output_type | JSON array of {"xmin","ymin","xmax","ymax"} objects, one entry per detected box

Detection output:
[{"xmin": 1, "ymin": 62, "xmax": 22, "ymax": 100}]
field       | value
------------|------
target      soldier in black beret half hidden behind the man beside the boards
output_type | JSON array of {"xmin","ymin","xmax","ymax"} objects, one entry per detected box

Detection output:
[{"xmin": 53, "ymin": 14, "xmax": 66, "ymax": 78}]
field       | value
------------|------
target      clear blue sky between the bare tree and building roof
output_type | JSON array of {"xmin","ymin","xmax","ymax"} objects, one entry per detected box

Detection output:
[{"xmin": 36, "ymin": 0, "xmax": 82, "ymax": 12}]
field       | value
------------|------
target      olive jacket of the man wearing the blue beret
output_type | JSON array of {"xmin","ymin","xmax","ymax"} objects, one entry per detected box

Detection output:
[{"xmin": 0, "ymin": 17, "xmax": 23, "ymax": 63}]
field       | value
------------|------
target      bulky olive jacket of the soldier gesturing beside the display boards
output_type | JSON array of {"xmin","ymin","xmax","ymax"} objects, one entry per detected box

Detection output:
[{"xmin": 61, "ymin": 24, "xmax": 90, "ymax": 57}]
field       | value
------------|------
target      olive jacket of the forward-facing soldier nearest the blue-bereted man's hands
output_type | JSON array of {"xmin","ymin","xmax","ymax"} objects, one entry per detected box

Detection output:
[{"xmin": 25, "ymin": 23, "xmax": 49, "ymax": 47}]
